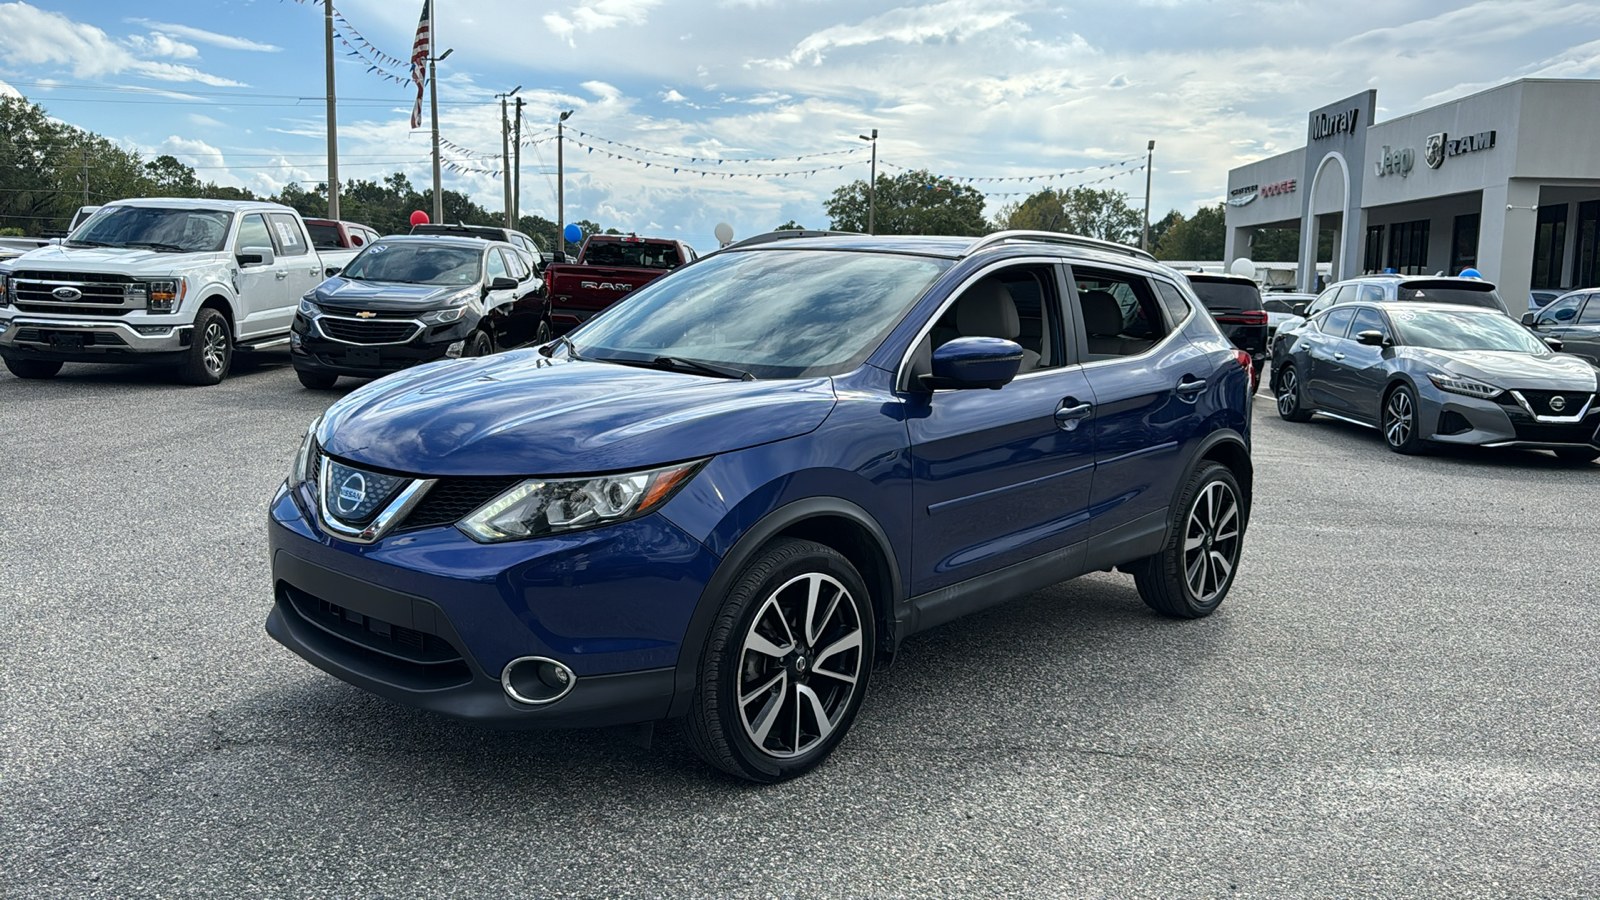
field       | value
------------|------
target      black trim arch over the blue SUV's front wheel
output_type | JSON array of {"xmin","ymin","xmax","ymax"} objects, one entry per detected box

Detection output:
[{"xmin": 667, "ymin": 496, "xmax": 902, "ymax": 717}]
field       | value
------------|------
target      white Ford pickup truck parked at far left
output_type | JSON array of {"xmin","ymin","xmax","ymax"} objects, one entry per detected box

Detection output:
[{"xmin": 0, "ymin": 199, "xmax": 325, "ymax": 384}]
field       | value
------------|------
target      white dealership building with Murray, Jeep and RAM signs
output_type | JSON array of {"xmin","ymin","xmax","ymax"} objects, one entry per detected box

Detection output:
[{"xmin": 1226, "ymin": 78, "xmax": 1600, "ymax": 301}]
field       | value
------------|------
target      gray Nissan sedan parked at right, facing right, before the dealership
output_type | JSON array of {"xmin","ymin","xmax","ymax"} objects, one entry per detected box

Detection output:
[{"xmin": 1272, "ymin": 303, "xmax": 1600, "ymax": 461}]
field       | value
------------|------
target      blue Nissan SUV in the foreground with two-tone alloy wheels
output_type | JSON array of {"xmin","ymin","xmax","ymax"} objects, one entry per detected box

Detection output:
[{"xmin": 267, "ymin": 232, "xmax": 1251, "ymax": 781}]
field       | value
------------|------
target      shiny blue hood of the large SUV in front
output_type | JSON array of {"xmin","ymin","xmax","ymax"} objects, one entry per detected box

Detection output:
[{"xmin": 320, "ymin": 351, "xmax": 835, "ymax": 476}]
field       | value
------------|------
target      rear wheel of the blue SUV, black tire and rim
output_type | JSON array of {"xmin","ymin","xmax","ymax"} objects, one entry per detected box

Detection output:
[{"xmin": 1125, "ymin": 461, "xmax": 1248, "ymax": 618}]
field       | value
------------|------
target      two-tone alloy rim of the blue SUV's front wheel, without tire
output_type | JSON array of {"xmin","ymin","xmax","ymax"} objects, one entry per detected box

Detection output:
[{"xmin": 736, "ymin": 572, "xmax": 864, "ymax": 759}]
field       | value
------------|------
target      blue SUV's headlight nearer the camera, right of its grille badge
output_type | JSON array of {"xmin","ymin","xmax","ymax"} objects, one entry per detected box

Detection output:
[{"xmin": 456, "ymin": 460, "xmax": 706, "ymax": 543}]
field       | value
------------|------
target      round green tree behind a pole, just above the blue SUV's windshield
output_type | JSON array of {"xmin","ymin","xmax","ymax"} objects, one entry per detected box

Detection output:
[{"xmin": 826, "ymin": 170, "xmax": 989, "ymax": 235}]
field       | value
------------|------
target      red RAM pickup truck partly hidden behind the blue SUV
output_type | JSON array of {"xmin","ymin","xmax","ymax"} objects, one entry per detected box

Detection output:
[{"xmin": 544, "ymin": 234, "xmax": 694, "ymax": 333}]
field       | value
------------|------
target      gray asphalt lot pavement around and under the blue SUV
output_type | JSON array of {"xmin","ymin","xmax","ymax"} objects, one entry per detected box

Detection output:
[{"xmin": 0, "ymin": 356, "xmax": 1600, "ymax": 898}]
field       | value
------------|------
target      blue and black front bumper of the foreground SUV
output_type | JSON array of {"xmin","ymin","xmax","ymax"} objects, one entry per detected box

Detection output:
[{"xmin": 267, "ymin": 485, "xmax": 718, "ymax": 729}]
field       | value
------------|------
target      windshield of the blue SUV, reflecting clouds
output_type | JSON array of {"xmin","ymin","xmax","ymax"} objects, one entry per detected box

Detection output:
[{"xmin": 571, "ymin": 250, "xmax": 952, "ymax": 378}]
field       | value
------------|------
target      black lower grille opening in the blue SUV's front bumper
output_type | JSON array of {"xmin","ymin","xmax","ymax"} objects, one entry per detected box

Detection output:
[{"xmin": 278, "ymin": 581, "xmax": 472, "ymax": 690}]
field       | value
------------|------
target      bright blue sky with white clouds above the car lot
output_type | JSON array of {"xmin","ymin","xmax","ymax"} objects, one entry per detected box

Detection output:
[{"xmin": 0, "ymin": 0, "xmax": 1600, "ymax": 250}]
